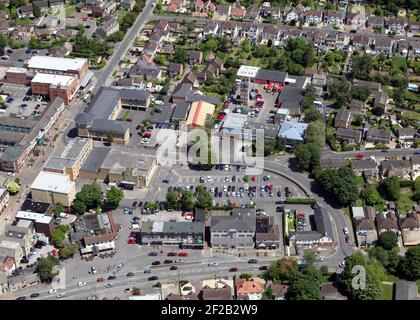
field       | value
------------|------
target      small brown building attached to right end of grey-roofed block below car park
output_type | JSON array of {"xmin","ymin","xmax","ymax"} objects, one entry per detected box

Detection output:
[{"xmin": 255, "ymin": 216, "xmax": 280, "ymax": 249}]
